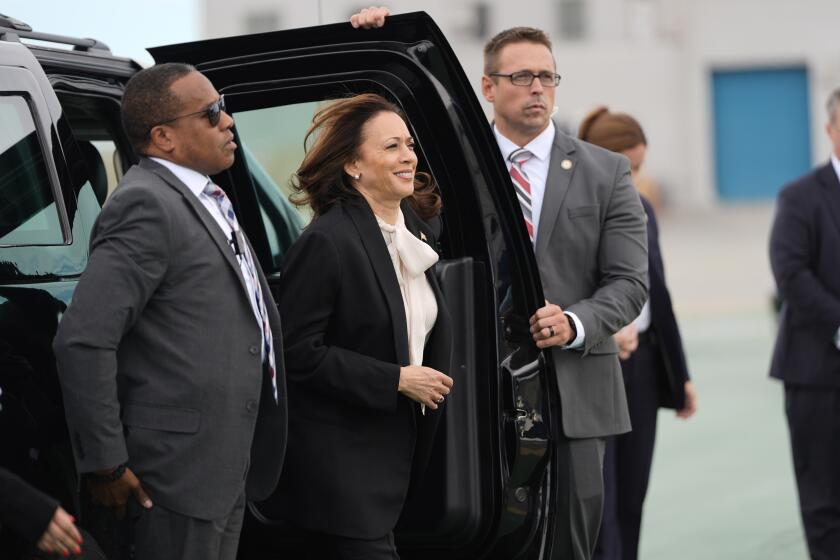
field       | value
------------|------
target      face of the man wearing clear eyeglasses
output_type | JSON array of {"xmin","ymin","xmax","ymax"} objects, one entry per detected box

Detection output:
[{"xmin": 481, "ymin": 42, "xmax": 556, "ymax": 146}]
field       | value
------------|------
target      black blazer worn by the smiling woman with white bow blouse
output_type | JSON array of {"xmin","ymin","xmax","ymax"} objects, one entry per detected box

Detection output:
[{"xmin": 270, "ymin": 197, "xmax": 451, "ymax": 539}]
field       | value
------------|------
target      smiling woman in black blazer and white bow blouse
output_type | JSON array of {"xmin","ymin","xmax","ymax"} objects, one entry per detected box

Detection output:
[{"xmin": 273, "ymin": 94, "xmax": 452, "ymax": 559}]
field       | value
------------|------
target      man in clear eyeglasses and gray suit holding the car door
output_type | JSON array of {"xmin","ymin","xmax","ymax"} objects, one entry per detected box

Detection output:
[{"xmin": 351, "ymin": 8, "xmax": 648, "ymax": 560}]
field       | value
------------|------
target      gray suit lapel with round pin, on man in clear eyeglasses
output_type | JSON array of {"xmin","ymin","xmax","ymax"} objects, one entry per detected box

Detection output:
[{"xmin": 535, "ymin": 130, "xmax": 577, "ymax": 260}]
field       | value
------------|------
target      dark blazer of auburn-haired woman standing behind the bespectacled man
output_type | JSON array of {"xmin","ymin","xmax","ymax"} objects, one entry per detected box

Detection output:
[{"xmin": 639, "ymin": 196, "xmax": 689, "ymax": 410}]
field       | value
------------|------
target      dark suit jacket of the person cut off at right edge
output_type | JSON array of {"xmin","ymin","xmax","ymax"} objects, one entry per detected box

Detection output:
[{"xmin": 770, "ymin": 162, "xmax": 840, "ymax": 387}]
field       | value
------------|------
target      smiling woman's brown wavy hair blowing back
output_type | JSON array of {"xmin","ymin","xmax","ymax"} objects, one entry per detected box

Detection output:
[{"xmin": 289, "ymin": 93, "xmax": 442, "ymax": 220}]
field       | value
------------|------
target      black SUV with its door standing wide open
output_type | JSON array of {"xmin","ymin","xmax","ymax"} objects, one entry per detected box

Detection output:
[{"xmin": 0, "ymin": 13, "xmax": 559, "ymax": 560}]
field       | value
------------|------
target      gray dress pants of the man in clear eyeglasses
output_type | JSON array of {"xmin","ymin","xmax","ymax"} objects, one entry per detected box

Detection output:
[{"xmin": 552, "ymin": 434, "xmax": 605, "ymax": 560}]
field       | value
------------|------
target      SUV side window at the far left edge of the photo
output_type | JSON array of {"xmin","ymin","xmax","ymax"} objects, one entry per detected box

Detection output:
[{"xmin": 0, "ymin": 95, "xmax": 64, "ymax": 246}]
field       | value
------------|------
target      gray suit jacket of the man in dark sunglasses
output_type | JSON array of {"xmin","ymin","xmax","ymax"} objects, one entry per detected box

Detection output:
[{"xmin": 54, "ymin": 159, "xmax": 286, "ymax": 519}]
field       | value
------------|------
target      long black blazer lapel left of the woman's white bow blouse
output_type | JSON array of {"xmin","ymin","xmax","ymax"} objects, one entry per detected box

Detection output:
[{"xmin": 343, "ymin": 196, "xmax": 408, "ymax": 365}]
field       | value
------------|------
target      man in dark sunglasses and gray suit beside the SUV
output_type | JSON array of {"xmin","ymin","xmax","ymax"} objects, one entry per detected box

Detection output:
[{"xmin": 54, "ymin": 64, "xmax": 286, "ymax": 560}]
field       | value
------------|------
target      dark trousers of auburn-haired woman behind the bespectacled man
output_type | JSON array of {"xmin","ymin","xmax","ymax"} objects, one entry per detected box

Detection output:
[{"xmin": 593, "ymin": 343, "xmax": 660, "ymax": 560}]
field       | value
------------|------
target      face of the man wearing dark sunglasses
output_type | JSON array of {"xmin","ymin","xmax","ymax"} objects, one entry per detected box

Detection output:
[{"xmin": 148, "ymin": 72, "xmax": 236, "ymax": 175}]
